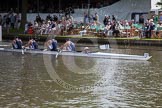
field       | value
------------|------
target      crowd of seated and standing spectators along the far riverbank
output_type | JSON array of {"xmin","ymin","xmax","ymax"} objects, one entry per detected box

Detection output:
[{"xmin": 0, "ymin": 9, "xmax": 162, "ymax": 38}]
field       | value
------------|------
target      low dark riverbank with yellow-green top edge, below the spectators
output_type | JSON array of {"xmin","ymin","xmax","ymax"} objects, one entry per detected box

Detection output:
[{"xmin": 2, "ymin": 34, "xmax": 162, "ymax": 46}]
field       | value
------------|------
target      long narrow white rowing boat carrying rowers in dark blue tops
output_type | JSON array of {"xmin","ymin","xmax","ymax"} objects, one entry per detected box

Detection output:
[{"xmin": 0, "ymin": 48, "xmax": 152, "ymax": 61}]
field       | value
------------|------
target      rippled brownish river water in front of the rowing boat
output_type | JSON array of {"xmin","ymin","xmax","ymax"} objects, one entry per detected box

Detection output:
[{"xmin": 0, "ymin": 41, "xmax": 162, "ymax": 108}]
